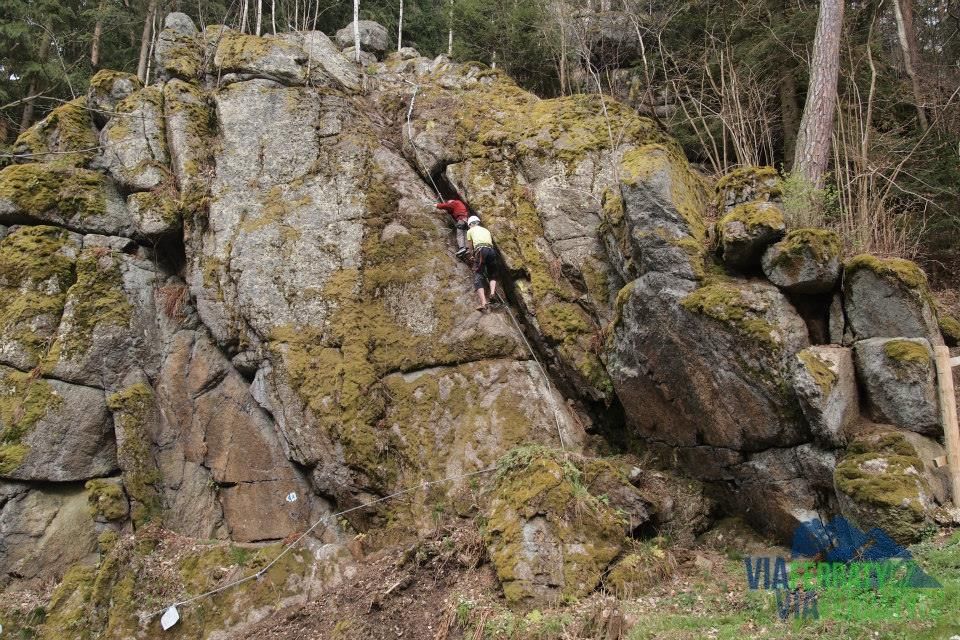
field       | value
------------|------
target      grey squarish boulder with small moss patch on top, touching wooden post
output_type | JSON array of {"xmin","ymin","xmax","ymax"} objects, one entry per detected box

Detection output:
[{"xmin": 853, "ymin": 338, "xmax": 942, "ymax": 436}]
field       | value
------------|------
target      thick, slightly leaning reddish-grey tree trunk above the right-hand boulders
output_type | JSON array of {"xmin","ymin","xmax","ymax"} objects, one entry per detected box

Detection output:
[{"xmin": 793, "ymin": 0, "xmax": 844, "ymax": 189}]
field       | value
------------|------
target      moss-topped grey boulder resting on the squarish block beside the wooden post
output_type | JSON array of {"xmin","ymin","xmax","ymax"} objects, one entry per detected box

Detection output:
[{"xmin": 843, "ymin": 254, "xmax": 943, "ymax": 345}]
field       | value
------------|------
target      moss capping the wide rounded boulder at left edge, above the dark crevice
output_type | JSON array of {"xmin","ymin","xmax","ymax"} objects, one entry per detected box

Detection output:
[{"xmin": 0, "ymin": 163, "xmax": 107, "ymax": 220}]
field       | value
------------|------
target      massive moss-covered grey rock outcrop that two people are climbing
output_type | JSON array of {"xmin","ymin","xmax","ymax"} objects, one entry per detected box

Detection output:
[{"xmin": 0, "ymin": 14, "xmax": 960, "ymax": 638}]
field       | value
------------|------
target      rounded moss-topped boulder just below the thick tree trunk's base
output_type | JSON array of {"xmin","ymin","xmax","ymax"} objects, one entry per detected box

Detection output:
[{"xmin": 763, "ymin": 229, "xmax": 840, "ymax": 294}]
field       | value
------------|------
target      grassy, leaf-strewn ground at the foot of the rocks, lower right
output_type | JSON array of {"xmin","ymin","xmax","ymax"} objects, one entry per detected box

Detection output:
[{"xmin": 451, "ymin": 532, "xmax": 960, "ymax": 640}]
